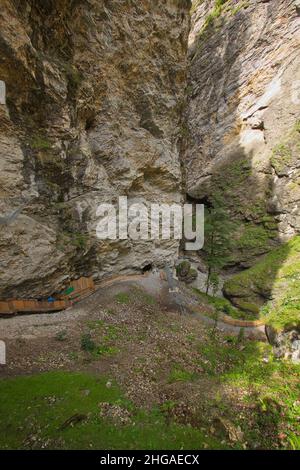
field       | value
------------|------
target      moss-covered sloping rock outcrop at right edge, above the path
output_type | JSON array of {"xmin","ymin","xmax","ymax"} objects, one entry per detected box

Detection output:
[{"xmin": 224, "ymin": 236, "xmax": 300, "ymax": 330}]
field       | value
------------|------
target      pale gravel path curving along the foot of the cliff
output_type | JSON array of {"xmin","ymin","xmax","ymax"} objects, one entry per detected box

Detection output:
[{"xmin": 0, "ymin": 273, "xmax": 265, "ymax": 340}]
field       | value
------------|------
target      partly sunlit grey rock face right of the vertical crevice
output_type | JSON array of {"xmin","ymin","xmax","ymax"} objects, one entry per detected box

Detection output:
[{"xmin": 184, "ymin": 0, "xmax": 300, "ymax": 267}]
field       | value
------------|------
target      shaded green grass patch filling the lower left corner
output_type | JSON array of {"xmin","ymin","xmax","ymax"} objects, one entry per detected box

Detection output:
[{"xmin": 0, "ymin": 372, "xmax": 225, "ymax": 450}]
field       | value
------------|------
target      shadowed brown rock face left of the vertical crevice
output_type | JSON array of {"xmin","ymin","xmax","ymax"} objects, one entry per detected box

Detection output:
[{"xmin": 0, "ymin": 0, "xmax": 190, "ymax": 297}]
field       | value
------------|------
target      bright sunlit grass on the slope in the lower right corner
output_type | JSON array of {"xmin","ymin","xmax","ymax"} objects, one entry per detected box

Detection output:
[{"xmin": 198, "ymin": 338, "xmax": 300, "ymax": 449}]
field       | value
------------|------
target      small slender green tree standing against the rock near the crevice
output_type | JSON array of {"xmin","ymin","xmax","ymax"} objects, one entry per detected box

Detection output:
[{"xmin": 204, "ymin": 194, "xmax": 235, "ymax": 295}]
